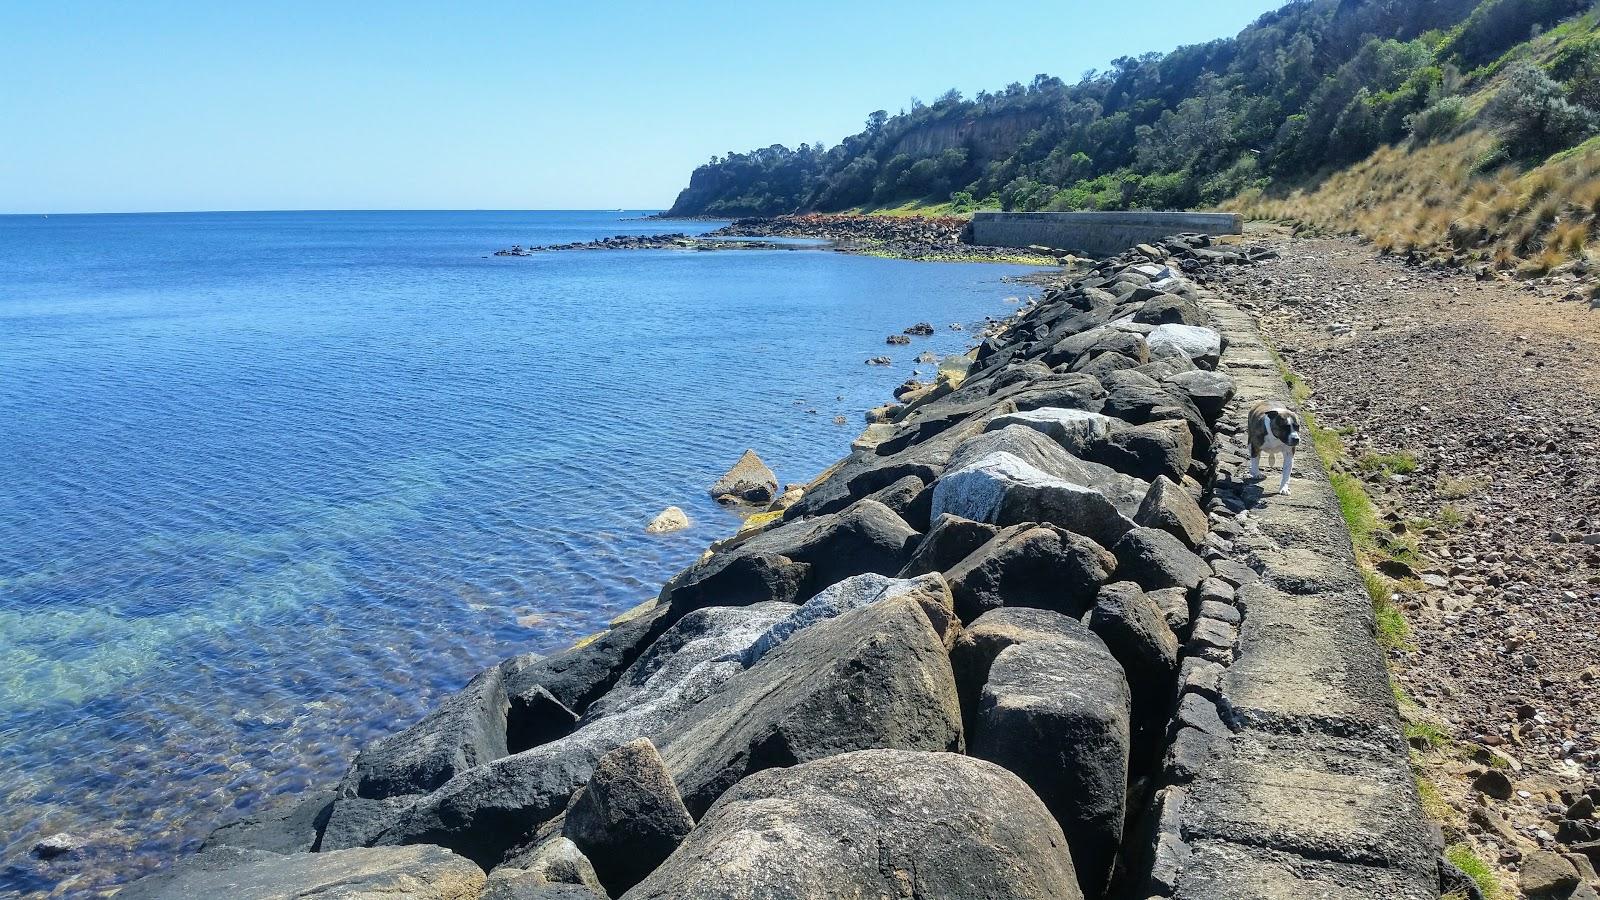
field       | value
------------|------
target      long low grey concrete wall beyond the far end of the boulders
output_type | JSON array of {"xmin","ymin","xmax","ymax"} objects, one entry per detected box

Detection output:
[{"xmin": 971, "ymin": 211, "xmax": 1245, "ymax": 256}]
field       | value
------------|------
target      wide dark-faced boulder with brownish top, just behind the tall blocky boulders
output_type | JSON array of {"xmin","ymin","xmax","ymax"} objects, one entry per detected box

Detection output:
[{"xmin": 949, "ymin": 525, "xmax": 1117, "ymax": 621}]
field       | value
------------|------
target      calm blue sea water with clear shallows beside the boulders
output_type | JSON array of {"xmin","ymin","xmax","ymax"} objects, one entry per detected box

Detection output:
[{"xmin": 0, "ymin": 213, "xmax": 1026, "ymax": 895}]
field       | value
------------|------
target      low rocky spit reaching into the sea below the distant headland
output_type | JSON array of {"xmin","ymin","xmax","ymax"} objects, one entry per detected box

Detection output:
[{"xmin": 494, "ymin": 213, "xmax": 1061, "ymax": 266}]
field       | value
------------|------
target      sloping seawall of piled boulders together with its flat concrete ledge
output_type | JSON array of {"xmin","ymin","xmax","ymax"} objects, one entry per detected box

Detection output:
[{"xmin": 136, "ymin": 235, "xmax": 1438, "ymax": 900}]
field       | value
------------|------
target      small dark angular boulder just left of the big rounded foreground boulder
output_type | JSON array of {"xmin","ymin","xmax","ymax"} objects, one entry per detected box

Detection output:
[{"xmin": 563, "ymin": 738, "xmax": 694, "ymax": 895}]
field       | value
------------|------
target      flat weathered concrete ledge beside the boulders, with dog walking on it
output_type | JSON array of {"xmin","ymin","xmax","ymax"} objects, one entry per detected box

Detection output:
[{"xmin": 1150, "ymin": 285, "xmax": 1438, "ymax": 900}]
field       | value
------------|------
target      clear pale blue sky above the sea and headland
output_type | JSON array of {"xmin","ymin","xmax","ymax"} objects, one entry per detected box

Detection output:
[{"xmin": 0, "ymin": 0, "xmax": 1278, "ymax": 213}]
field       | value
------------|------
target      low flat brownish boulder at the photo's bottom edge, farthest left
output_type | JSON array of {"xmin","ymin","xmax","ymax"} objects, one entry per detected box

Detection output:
[{"xmin": 117, "ymin": 846, "xmax": 485, "ymax": 900}]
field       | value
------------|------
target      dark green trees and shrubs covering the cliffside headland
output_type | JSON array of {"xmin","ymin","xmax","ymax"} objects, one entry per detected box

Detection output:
[{"xmin": 670, "ymin": 0, "xmax": 1600, "ymax": 227}]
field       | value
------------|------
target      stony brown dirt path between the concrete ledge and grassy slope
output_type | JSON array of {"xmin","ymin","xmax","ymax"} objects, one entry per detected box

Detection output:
[{"xmin": 1209, "ymin": 234, "xmax": 1600, "ymax": 886}]
